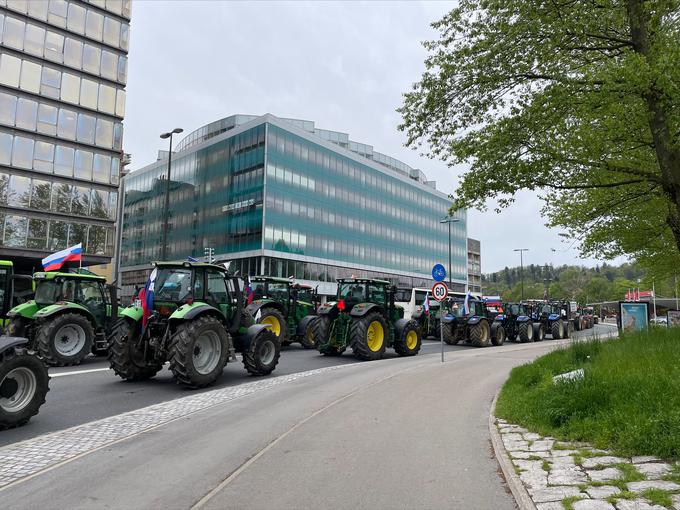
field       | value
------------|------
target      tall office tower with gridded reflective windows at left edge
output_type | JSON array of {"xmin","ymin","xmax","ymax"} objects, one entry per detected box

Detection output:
[{"xmin": 0, "ymin": 0, "xmax": 130, "ymax": 271}]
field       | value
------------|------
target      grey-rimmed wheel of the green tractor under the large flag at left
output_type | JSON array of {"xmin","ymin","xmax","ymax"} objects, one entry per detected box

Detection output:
[{"xmin": 35, "ymin": 313, "xmax": 94, "ymax": 367}]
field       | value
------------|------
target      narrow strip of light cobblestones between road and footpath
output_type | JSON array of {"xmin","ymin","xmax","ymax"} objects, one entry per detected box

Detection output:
[{"xmin": 0, "ymin": 365, "xmax": 350, "ymax": 490}]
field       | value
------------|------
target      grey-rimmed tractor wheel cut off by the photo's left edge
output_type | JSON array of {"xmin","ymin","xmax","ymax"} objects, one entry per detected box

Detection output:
[{"xmin": 0, "ymin": 348, "xmax": 50, "ymax": 430}]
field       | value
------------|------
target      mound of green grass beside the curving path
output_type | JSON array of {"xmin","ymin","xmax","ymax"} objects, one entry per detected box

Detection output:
[{"xmin": 496, "ymin": 328, "xmax": 680, "ymax": 460}]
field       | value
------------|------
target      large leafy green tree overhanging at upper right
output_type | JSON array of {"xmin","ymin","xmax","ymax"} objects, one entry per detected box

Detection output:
[{"xmin": 399, "ymin": 0, "xmax": 680, "ymax": 274}]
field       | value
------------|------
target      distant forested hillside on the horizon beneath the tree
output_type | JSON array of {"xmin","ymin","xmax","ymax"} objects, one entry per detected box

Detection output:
[{"xmin": 482, "ymin": 263, "xmax": 680, "ymax": 303}]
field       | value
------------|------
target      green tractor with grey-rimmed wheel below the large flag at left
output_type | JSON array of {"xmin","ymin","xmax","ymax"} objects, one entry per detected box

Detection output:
[{"xmin": 7, "ymin": 272, "xmax": 118, "ymax": 366}]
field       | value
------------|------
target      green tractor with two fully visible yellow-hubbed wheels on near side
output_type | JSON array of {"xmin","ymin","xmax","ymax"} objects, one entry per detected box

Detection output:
[{"xmin": 312, "ymin": 278, "xmax": 422, "ymax": 361}]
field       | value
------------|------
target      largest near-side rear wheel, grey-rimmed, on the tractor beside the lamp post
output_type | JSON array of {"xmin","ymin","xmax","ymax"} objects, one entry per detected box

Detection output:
[{"xmin": 169, "ymin": 315, "xmax": 229, "ymax": 388}]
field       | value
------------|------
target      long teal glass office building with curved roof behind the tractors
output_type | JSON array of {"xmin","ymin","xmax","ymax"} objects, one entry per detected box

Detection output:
[{"xmin": 121, "ymin": 115, "xmax": 467, "ymax": 296}]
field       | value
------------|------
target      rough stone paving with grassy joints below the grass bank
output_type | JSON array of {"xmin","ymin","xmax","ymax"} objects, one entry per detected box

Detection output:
[{"xmin": 496, "ymin": 419, "xmax": 680, "ymax": 510}]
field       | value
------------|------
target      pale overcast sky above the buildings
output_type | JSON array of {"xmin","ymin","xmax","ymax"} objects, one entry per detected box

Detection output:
[{"xmin": 124, "ymin": 0, "xmax": 628, "ymax": 273}]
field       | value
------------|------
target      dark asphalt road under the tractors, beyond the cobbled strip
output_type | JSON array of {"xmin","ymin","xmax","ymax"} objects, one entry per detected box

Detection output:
[{"xmin": 0, "ymin": 326, "xmax": 612, "ymax": 447}]
